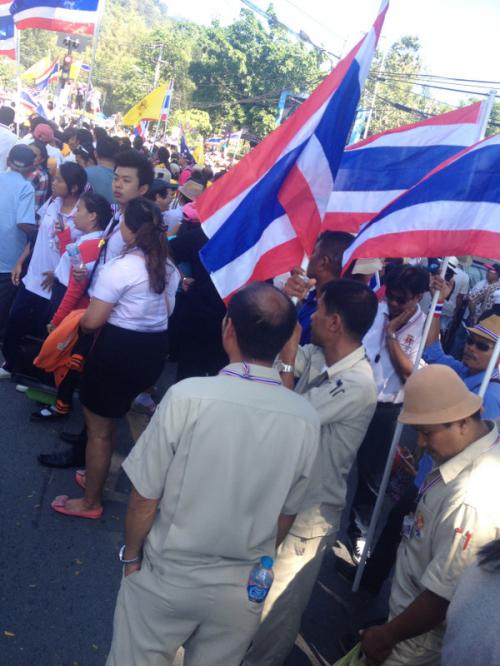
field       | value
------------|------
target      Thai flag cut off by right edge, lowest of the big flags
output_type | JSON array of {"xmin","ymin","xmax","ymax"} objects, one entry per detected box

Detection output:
[{"xmin": 344, "ymin": 134, "xmax": 500, "ymax": 266}]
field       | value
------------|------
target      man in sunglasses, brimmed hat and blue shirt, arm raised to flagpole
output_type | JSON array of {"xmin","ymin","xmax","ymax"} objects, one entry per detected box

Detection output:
[{"xmin": 424, "ymin": 275, "xmax": 500, "ymax": 419}]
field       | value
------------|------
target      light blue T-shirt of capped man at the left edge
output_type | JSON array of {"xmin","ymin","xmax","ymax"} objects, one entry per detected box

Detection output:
[{"xmin": 0, "ymin": 171, "xmax": 36, "ymax": 273}]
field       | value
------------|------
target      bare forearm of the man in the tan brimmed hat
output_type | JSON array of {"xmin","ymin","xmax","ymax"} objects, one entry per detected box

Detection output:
[{"xmin": 361, "ymin": 590, "xmax": 450, "ymax": 666}]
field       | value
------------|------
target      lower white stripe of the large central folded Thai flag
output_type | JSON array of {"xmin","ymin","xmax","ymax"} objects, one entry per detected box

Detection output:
[{"xmin": 210, "ymin": 215, "xmax": 296, "ymax": 298}]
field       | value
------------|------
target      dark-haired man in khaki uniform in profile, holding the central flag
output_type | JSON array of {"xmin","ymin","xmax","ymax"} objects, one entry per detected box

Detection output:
[{"xmin": 243, "ymin": 280, "xmax": 377, "ymax": 666}]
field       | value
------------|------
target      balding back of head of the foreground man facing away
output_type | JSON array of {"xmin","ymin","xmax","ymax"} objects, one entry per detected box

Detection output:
[{"xmin": 227, "ymin": 282, "xmax": 297, "ymax": 362}]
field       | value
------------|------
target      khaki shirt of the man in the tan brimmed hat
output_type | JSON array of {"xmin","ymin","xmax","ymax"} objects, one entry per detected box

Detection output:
[{"xmin": 389, "ymin": 421, "xmax": 500, "ymax": 635}]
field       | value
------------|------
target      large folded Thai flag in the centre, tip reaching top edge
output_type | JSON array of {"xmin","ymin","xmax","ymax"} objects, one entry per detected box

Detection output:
[{"xmin": 197, "ymin": 1, "xmax": 388, "ymax": 299}]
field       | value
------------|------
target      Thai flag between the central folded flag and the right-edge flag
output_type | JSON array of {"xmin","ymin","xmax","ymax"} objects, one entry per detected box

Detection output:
[{"xmin": 323, "ymin": 102, "xmax": 485, "ymax": 233}]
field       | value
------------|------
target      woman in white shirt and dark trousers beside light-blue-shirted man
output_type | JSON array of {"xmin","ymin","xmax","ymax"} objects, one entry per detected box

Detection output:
[{"xmin": 0, "ymin": 164, "xmax": 87, "ymax": 378}]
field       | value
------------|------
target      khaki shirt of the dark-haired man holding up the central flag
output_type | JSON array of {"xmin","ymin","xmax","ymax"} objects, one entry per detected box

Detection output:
[{"xmin": 291, "ymin": 345, "xmax": 377, "ymax": 538}]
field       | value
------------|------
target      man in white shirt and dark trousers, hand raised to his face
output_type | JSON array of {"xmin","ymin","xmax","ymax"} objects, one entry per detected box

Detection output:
[{"xmin": 348, "ymin": 264, "xmax": 429, "ymax": 560}]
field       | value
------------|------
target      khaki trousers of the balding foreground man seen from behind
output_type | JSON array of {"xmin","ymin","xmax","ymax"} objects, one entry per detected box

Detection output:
[{"xmin": 106, "ymin": 564, "xmax": 261, "ymax": 666}]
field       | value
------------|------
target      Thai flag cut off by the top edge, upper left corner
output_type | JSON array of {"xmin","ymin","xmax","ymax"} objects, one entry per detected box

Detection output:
[{"xmin": 10, "ymin": 0, "xmax": 99, "ymax": 35}]
